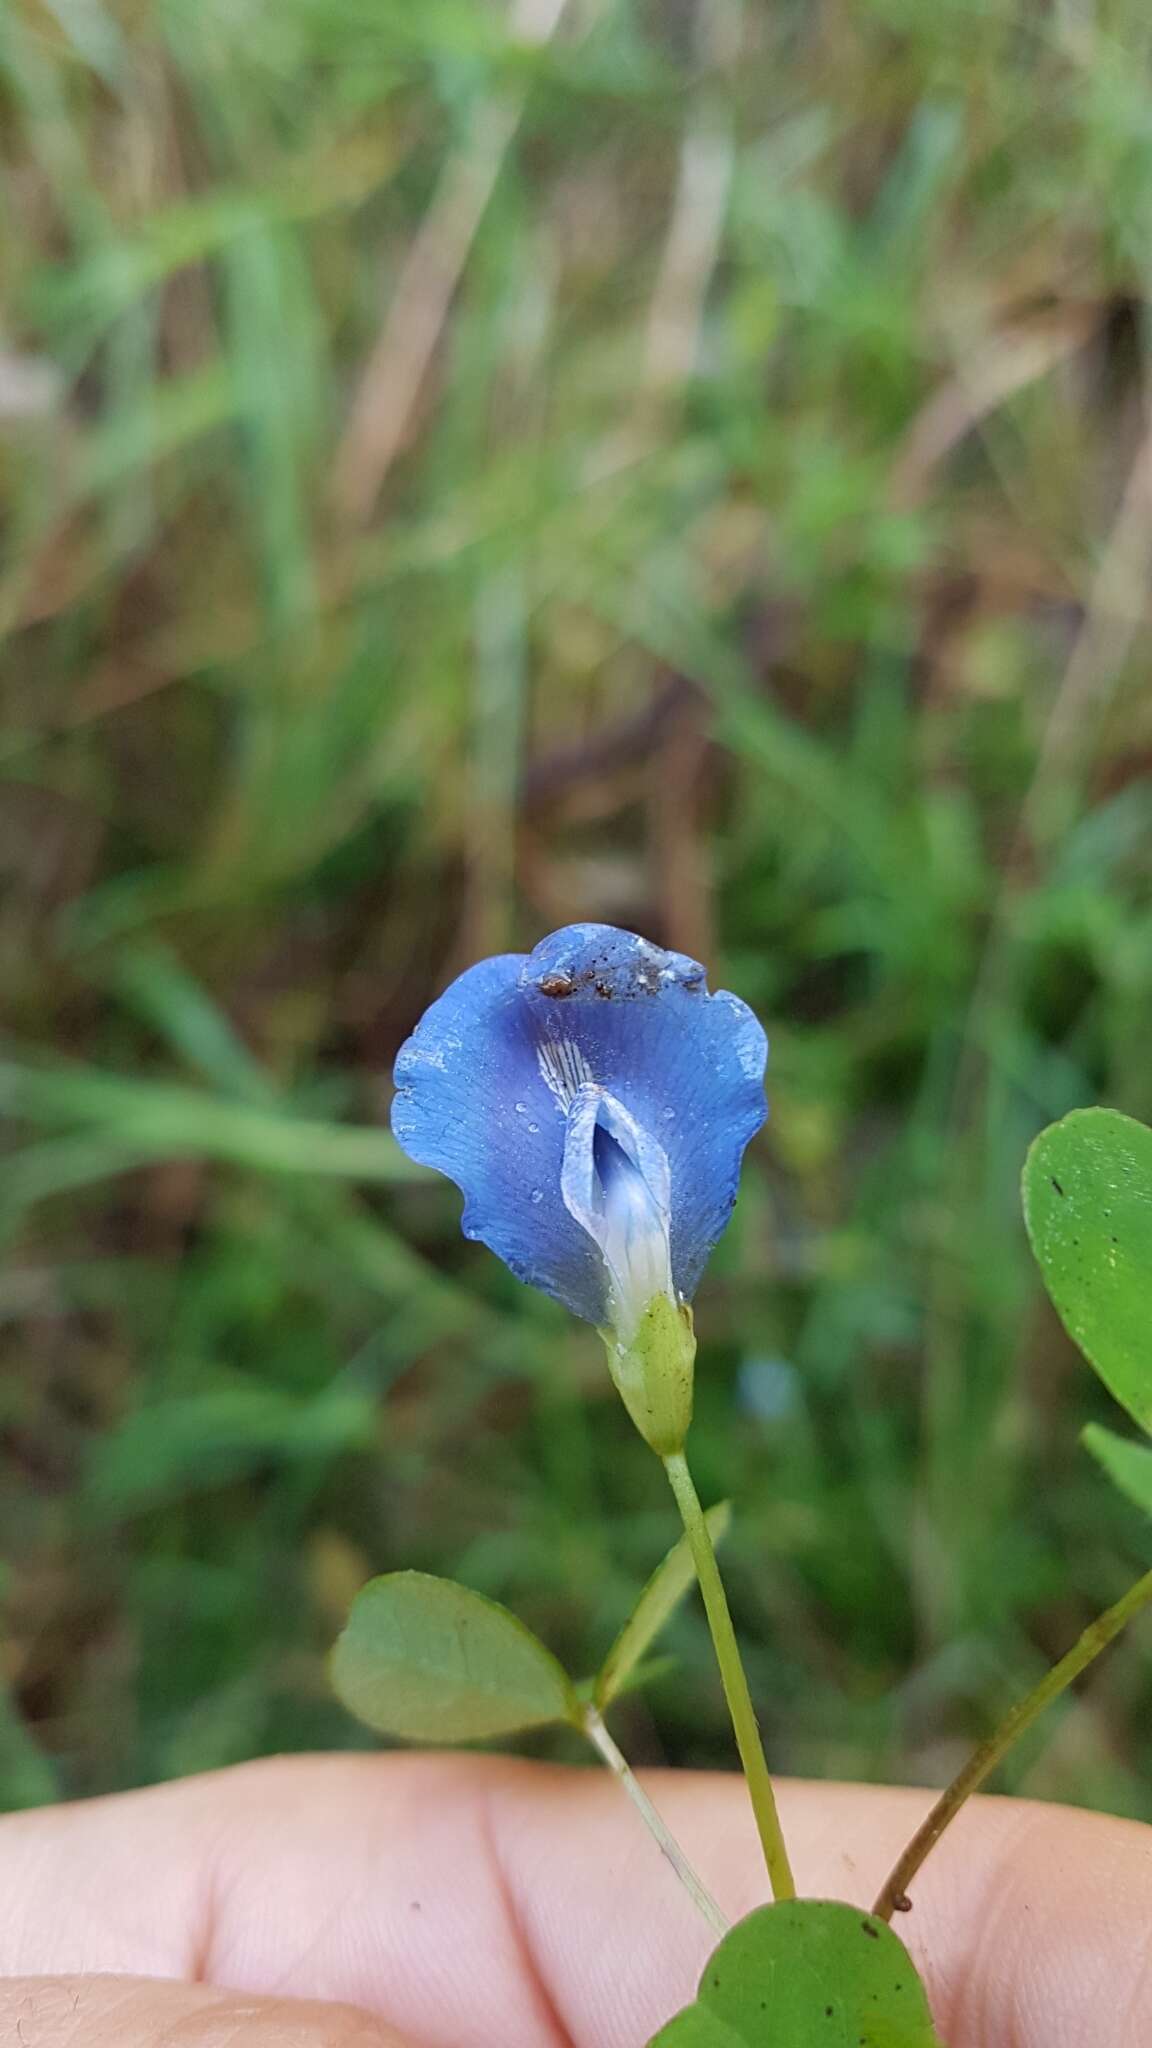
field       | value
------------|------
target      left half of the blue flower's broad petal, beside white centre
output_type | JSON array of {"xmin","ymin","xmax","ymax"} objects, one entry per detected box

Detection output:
[{"xmin": 392, "ymin": 952, "xmax": 607, "ymax": 1323}]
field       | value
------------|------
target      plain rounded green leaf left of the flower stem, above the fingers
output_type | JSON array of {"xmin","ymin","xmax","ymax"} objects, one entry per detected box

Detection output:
[{"xmin": 332, "ymin": 1571, "xmax": 582, "ymax": 1743}]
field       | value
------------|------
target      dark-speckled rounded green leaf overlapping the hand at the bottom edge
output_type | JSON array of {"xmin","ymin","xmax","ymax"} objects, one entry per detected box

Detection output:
[{"xmin": 650, "ymin": 1898, "xmax": 941, "ymax": 2048}]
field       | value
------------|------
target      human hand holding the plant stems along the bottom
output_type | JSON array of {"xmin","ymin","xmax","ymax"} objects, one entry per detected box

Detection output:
[{"xmin": 0, "ymin": 1755, "xmax": 1152, "ymax": 2048}]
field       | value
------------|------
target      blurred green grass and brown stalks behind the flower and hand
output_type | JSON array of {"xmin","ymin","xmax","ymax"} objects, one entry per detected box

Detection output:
[{"xmin": 0, "ymin": 0, "xmax": 1152, "ymax": 1817}]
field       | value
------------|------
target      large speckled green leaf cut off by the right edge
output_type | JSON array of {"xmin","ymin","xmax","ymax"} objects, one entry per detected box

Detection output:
[{"xmin": 1023, "ymin": 1110, "xmax": 1152, "ymax": 1432}]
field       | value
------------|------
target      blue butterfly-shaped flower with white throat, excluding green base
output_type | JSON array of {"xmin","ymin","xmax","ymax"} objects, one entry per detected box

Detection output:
[{"xmin": 392, "ymin": 924, "xmax": 767, "ymax": 1351}]
